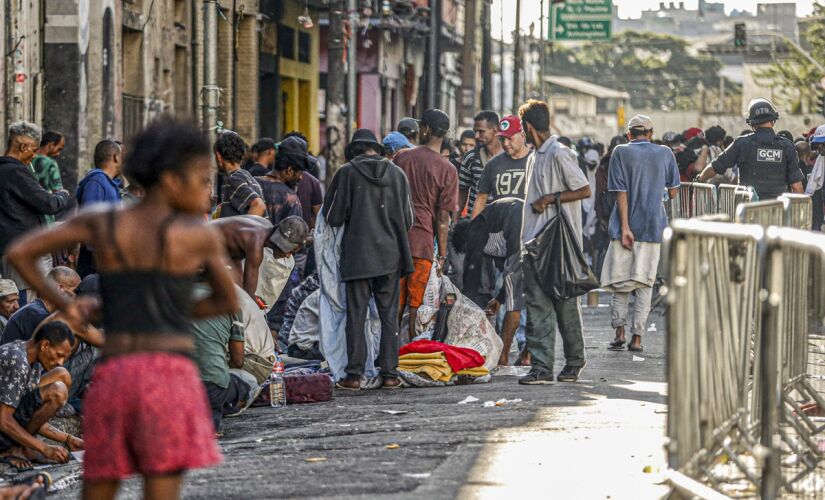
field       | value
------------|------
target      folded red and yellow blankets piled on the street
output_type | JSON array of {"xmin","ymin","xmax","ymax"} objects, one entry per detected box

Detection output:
[{"xmin": 398, "ymin": 340, "xmax": 490, "ymax": 387}]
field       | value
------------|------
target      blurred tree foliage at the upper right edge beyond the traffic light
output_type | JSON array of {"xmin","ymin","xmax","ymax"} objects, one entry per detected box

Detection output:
[{"xmin": 756, "ymin": 3, "xmax": 825, "ymax": 113}]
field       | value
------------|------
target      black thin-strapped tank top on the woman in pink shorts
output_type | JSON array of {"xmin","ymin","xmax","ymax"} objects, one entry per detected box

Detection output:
[{"xmin": 100, "ymin": 210, "xmax": 196, "ymax": 335}]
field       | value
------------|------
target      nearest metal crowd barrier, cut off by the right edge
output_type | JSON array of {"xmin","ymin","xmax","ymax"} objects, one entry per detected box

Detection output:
[{"xmin": 754, "ymin": 227, "xmax": 825, "ymax": 499}]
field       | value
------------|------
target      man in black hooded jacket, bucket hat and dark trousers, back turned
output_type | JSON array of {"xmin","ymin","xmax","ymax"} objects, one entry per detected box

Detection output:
[{"xmin": 323, "ymin": 129, "xmax": 412, "ymax": 390}]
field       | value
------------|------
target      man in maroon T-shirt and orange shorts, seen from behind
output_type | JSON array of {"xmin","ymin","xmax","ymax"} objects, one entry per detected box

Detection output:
[{"xmin": 395, "ymin": 109, "xmax": 458, "ymax": 339}]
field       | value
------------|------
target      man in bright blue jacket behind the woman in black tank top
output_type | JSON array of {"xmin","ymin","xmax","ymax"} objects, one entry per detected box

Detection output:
[{"xmin": 75, "ymin": 139, "xmax": 123, "ymax": 278}]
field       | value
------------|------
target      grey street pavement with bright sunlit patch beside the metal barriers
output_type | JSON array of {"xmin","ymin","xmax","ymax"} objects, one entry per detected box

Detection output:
[{"xmin": 41, "ymin": 298, "xmax": 667, "ymax": 500}]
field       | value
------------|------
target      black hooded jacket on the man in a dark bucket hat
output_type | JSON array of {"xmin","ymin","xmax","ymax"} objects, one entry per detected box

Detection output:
[{"xmin": 322, "ymin": 155, "xmax": 414, "ymax": 281}]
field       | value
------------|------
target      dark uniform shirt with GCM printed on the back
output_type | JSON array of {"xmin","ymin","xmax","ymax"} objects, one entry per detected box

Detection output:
[{"xmin": 711, "ymin": 127, "xmax": 804, "ymax": 200}]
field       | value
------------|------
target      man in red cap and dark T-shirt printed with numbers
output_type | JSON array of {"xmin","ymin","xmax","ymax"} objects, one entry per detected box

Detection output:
[{"xmin": 473, "ymin": 115, "xmax": 530, "ymax": 219}]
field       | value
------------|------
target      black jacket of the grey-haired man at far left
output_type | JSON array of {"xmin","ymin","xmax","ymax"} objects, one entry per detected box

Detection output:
[{"xmin": 0, "ymin": 156, "xmax": 69, "ymax": 255}]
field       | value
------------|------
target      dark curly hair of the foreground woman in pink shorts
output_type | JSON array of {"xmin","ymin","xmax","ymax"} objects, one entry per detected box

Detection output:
[{"xmin": 123, "ymin": 115, "xmax": 210, "ymax": 189}]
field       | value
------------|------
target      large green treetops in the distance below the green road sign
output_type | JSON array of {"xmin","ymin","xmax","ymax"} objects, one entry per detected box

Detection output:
[{"xmin": 549, "ymin": 31, "xmax": 738, "ymax": 110}]
